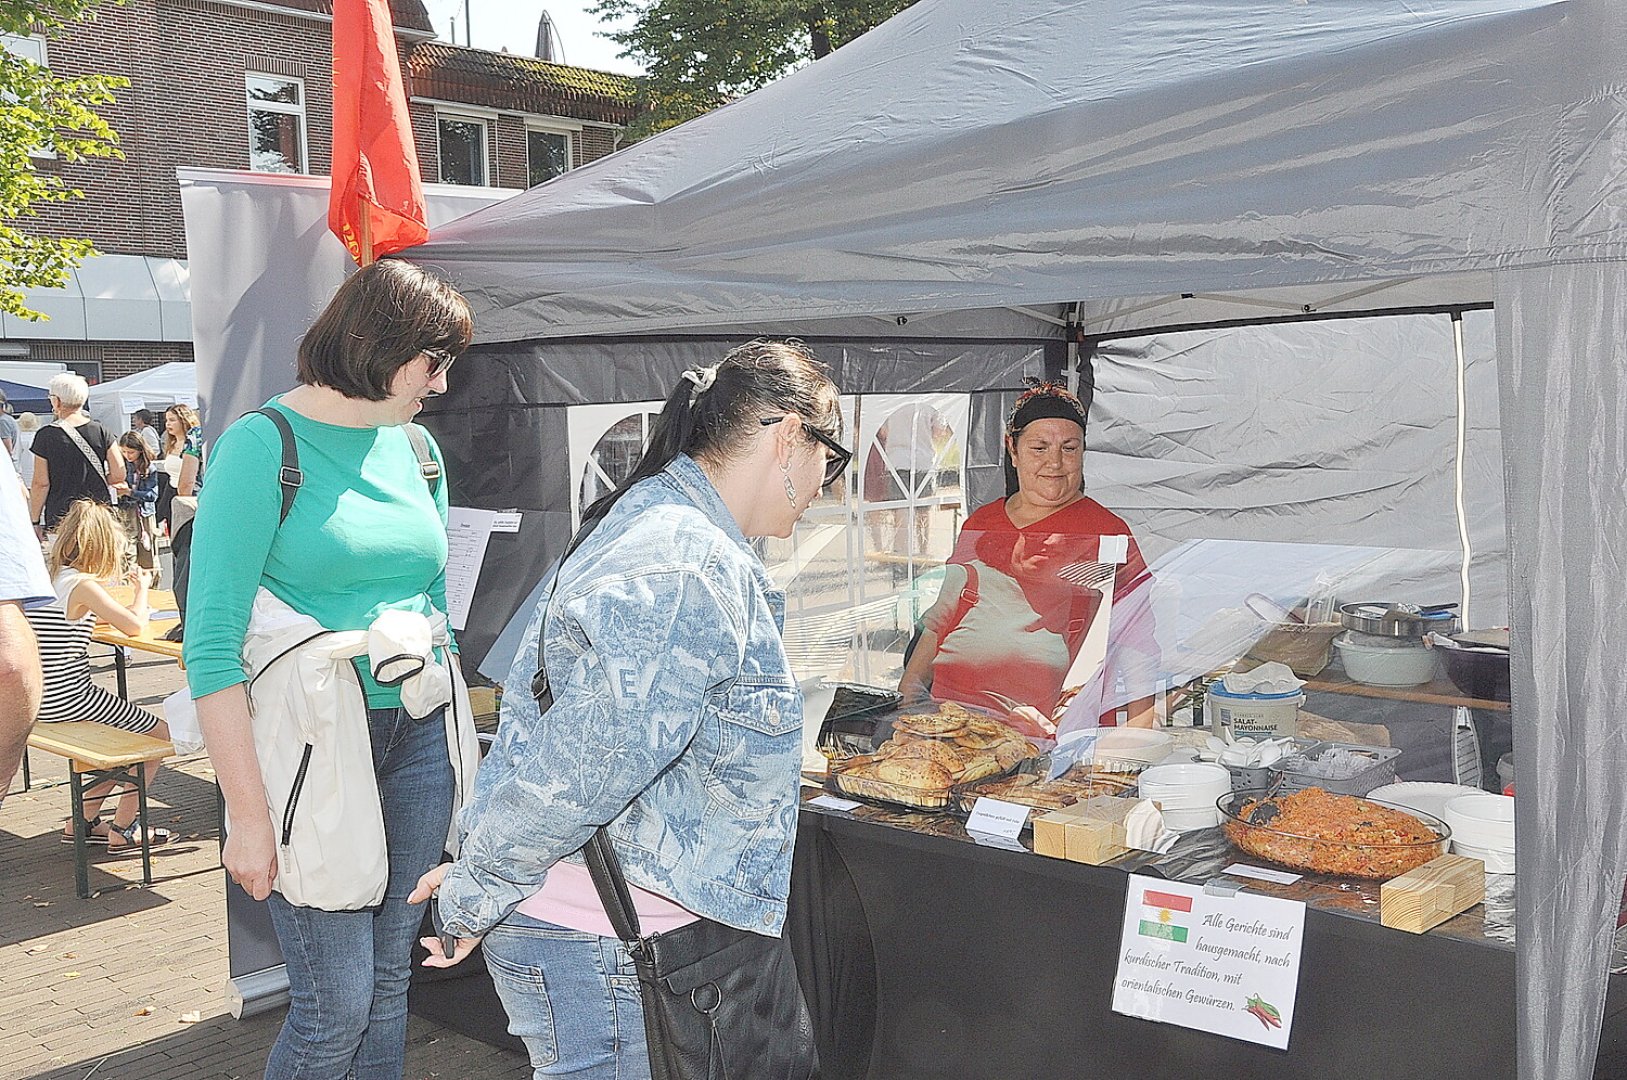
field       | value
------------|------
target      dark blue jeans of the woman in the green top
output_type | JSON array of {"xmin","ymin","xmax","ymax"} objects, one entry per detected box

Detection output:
[{"xmin": 265, "ymin": 709, "xmax": 452, "ymax": 1080}]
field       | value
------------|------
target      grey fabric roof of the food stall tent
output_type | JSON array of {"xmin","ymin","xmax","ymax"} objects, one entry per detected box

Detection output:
[{"xmin": 415, "ymin": 0, "xmax": 1627, "ymax": 342}]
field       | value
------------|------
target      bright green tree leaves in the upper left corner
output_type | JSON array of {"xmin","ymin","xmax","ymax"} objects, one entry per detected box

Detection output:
[{"xmin": 0, "ymin": 0, "xmax": 129, "ymax": 319}]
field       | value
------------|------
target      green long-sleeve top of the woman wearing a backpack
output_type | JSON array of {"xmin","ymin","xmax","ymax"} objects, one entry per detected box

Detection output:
[{"xmin": 182, "ymin": 397, "xmax": 446, "ymax": 709}]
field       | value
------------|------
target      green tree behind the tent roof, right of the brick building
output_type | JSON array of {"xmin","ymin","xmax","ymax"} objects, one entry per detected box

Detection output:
[{"xmin": 592, "ymin": 0, "xmax": 914, "ymax": 137}]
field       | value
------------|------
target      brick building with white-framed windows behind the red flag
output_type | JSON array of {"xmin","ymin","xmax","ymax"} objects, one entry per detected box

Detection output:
[{"xmin": 0, "ymin": 0, "xmax": 636, "ymax": 379}]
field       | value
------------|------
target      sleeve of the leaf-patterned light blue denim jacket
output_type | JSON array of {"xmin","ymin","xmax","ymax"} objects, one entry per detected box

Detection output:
[{"xmin": 438, "ymin": 568, "xmax": 744, "ymax": 937}]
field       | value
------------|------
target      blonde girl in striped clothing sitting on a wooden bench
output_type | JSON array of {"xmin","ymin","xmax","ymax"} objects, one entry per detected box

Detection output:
[{"xmin": 24, "ymin": 499, "xmax": 171, "ymax": 851}]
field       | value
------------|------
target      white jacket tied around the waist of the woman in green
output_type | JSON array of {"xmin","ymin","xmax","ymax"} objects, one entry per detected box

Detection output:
[{"xmin": 240, "ymin": 589, "xmax": 480, "ymax": 911}]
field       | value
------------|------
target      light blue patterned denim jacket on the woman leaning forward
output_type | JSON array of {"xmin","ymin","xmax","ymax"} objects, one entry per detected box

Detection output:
[{"xmin": 438, "ymin": 455, "xmax": 802, "ymax": 937}]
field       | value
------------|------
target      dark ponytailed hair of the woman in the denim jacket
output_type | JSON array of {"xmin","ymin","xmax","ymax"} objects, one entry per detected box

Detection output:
[{"xmin": 579, "ymin": 340, "xmax": 841, "ymax": 523}]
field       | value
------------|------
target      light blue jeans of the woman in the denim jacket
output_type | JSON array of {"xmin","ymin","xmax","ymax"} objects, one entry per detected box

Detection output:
[{"xmin": 482, "ymin": 911, "xmax": 649, "ymax": 1080}]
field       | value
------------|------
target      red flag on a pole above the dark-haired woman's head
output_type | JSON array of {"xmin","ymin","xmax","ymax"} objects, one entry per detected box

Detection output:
[{"xmin": 327, "ymin": 0, "xmax": 430, "ymax": 265}]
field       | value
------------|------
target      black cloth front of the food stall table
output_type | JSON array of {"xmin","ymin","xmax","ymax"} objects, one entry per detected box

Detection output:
[{"xmin": 787, "ymin": 793, "xmax": 1627, "ymax": 1080}]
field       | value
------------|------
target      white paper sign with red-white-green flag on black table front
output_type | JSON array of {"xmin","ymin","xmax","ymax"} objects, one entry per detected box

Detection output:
[{"xmin": 1113, "ymin": 873, "xmax": 1305, "ymax": 1049}]
